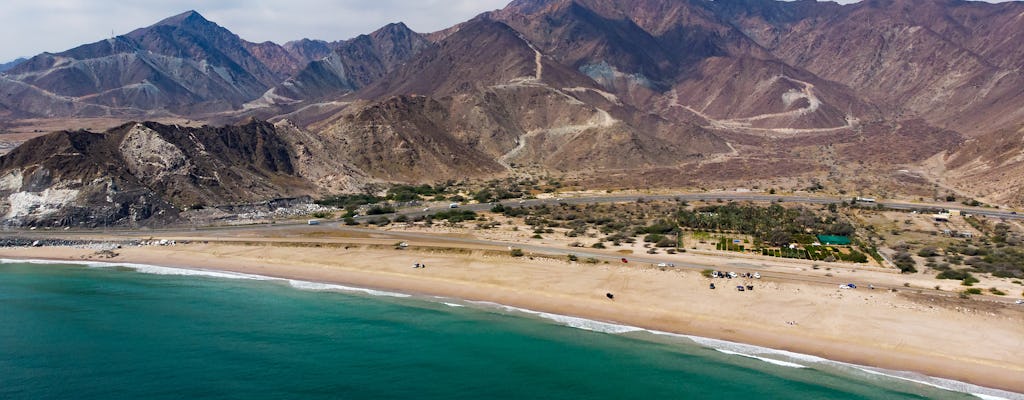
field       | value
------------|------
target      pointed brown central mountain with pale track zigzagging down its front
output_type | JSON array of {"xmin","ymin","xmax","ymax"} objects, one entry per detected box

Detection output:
[{"xmin": 309, "ymin": 18, "xmax": 728, "ymax": 180}]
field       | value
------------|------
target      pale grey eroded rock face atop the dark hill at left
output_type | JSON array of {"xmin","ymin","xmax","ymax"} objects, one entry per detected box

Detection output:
[{"xmin": 119, "ymin": 124, "xmax": 195, "ymax": 180}]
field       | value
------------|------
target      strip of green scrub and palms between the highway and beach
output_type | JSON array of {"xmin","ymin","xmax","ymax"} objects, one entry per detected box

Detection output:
[{"xmin": 321, "ymin": 186, "xmax": 1024, "ymax": 294}]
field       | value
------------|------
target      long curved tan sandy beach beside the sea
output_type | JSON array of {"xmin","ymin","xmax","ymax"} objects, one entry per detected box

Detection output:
[{"xmin": 0, "ymin": 243, "xmax": 1024, "ymax": 393}]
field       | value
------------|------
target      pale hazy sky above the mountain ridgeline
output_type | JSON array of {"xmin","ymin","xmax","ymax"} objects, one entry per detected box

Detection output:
[{"xmin": 0, "ymin": 0, "xmax": 1011, "ymax": 62}]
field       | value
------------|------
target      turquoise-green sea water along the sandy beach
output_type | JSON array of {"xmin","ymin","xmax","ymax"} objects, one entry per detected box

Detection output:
[{"xmin": 0, "ymin": 262, "xmax": 1015, "ymax": 400}]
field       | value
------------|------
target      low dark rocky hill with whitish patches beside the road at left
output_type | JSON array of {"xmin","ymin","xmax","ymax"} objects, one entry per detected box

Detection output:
[{"xmin": 0, "ymin": 122, "xmax": 312, "ymax": 226}]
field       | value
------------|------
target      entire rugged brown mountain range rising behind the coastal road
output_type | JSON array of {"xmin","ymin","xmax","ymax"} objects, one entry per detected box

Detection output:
[{"xmin": 0, "ymin": 0, "xmax": 1024, "ymax": 223}]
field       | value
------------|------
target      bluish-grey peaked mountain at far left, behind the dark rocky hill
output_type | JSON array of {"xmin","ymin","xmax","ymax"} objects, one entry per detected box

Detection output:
[{"xmin": 0, "ymin": 11, "xmax": 297, "ymax": 117}]
